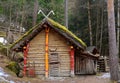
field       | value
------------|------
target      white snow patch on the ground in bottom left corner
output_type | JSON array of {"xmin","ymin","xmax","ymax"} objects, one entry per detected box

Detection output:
[{"xmin": 0, "ymin": 67, "xmax": 15, "ymax": 83}]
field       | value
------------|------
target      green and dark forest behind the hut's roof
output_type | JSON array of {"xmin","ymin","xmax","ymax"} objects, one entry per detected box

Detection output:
[{"xmin": 0, "ymin": 0, "xmax": 118, "ymax": 56}]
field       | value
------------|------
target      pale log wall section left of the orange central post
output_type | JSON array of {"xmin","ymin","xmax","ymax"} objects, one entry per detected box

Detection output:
[{"xmin": 27, "ymin": 30, "xmax": 45, "ymax": 76}]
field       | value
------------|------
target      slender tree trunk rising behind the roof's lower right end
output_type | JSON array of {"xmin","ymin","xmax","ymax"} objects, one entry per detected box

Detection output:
[{"xmin": 88, "ymin": 1, "xmax": 93, "ymax": 46}]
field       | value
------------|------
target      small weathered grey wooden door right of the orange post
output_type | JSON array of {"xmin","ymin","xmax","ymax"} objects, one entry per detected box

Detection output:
[{"xmin": 49, "ymin": 52, "xmax": 60, "ymax": 76}]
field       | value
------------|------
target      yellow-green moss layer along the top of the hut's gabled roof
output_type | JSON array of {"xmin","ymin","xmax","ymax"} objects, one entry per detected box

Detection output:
[{"xmin": 11, "ymin": 18, "xmax": 86, "ymax": 48}]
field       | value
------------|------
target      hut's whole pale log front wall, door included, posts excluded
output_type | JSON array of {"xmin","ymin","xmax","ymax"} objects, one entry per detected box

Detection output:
[{"xmin": 27, "ymin": 29, "xmax": 70, "ymax": 76}]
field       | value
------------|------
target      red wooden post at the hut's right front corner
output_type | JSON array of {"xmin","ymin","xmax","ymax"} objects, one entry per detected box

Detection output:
[{"xmin": 70, "ymin": 46, "xmax": 74, "ymax": 77}]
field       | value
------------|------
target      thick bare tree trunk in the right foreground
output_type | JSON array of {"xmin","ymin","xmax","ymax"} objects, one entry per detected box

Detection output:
[{"xmin": 107, "ymin": 0, "xmax": 119, "ymax": 81}]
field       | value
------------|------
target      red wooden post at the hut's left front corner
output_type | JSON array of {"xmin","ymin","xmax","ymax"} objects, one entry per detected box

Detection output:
[{"xmin": 23, "ymin": 44, "xmax": 29, "ymax": 76}]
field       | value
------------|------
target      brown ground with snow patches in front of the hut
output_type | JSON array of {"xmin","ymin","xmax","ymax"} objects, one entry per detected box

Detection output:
[{"xmin": 0, "ymin": 55, "xmax": 111, "ymax": 83}]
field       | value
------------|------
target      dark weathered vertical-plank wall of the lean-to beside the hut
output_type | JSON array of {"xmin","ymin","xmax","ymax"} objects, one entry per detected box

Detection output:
[{"xmin": 75, "ymin": 56, "xmax": 97, "ymax": 75}]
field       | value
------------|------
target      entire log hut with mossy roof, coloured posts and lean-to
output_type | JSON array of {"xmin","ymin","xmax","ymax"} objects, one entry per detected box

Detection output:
[{"xmin": 11, "ymin": 19, "xmax": 98, "ymax": 78}]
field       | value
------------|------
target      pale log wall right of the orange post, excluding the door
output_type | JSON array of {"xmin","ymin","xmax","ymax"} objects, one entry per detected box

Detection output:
[{"xmin": 49, "ymin": 30, "xmax": 70, "ymax": 76}]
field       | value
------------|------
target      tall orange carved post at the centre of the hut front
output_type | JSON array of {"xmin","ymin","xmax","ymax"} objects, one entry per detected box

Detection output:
[{"xmin": 45, "ymin": 27, "xmax": 49, "ymax": 78}]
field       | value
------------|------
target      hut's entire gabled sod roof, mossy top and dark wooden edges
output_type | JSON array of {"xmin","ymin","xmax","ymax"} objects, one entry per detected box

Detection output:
[{"xmin": 11, "ymin": 18, "xmax": 86, "ymax": 49}]
